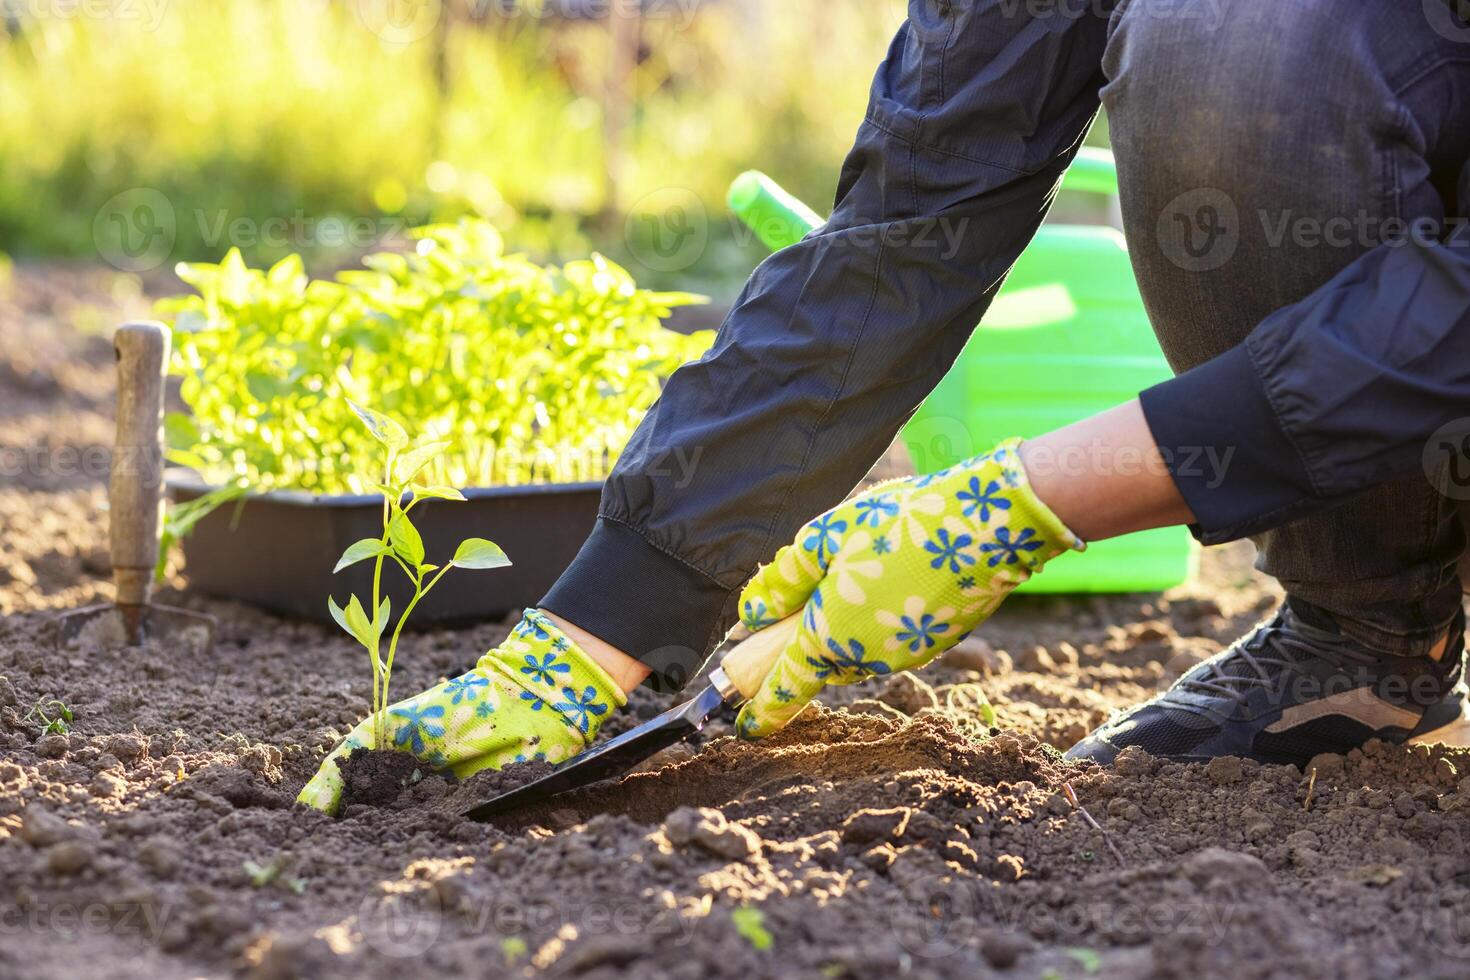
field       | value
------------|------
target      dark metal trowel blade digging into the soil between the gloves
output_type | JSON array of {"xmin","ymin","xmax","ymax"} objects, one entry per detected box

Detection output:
[{"xmin": 465, "ymin": 686, "xmax": 725, "ymax": 823}]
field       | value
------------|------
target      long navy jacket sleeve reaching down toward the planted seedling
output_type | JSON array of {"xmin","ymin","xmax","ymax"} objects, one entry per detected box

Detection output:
[{"xmin": 542, "ymin": 0, "xmax": 1110, "ymax": 688}]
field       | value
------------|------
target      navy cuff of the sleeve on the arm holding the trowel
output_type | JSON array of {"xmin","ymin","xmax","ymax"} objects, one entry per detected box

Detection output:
[{"xmin": 1139, "ymin": 344, "xmax": 1314, "ymax": 545}]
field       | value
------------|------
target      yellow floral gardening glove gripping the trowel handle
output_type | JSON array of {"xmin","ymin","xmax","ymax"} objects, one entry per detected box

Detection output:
[{"xmin": 736, "ymin": 439, "xmax": 1085, "ymax": 739}]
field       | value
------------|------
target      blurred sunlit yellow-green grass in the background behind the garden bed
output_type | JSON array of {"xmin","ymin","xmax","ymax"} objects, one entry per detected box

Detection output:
[{"xmin": 0, "ymin": 0, "xmax": 1105, "ymax": 297}]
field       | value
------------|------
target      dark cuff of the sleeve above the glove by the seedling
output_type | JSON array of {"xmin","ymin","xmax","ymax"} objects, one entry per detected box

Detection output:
[{"xmin": 541, "ymin": 517, "xmax": 735, "ymax": 692}]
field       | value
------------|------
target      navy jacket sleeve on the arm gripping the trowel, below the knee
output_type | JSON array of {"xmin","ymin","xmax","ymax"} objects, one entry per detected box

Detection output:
[{"xmin": 1142, "ymin": 229, "xmax": 1470, "ymax": 544}]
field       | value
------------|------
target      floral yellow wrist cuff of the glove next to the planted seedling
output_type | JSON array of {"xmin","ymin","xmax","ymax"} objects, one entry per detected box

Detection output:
[{"xmin": 478, "ymin": 610, "xmax": 628, "ymax": 745}]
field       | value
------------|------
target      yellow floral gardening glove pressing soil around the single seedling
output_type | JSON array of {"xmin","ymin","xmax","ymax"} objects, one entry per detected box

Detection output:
[{"xmin": 297, "ymin": 610, "xmax": 628, "ymax": 814}]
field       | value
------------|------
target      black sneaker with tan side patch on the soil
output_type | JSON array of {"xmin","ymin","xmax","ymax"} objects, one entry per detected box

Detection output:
[{"xmin": 1067, "ymin": 601, "xmax": 1466, "ymax": 767}]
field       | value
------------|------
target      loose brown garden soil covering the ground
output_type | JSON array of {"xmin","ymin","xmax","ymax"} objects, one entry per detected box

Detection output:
[{"xmin": 0, "ymin": 264, "xmax": 1470, "ymax": 980}]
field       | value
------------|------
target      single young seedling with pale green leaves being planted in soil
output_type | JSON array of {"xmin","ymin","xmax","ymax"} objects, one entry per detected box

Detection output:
[{"xmin": 326, "ymin": 403, "xmax": 510, "ymax": 749}]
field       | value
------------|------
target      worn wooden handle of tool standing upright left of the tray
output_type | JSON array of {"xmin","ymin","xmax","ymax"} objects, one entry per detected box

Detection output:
[{"xmin": 109, "ymin": 323, "xmax": 169, "ymax": 605}]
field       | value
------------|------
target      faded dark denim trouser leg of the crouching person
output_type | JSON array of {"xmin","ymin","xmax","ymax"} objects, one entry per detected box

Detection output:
[{"xmin": 1103, "ymin": 0, "xmax": 1470, "ymax": 654}]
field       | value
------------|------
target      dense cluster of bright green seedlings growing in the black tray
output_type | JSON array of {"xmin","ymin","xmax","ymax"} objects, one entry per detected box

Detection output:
[{"xmin": 159, "ymin": 219, "xmax": 714, "ymax": 494}]
